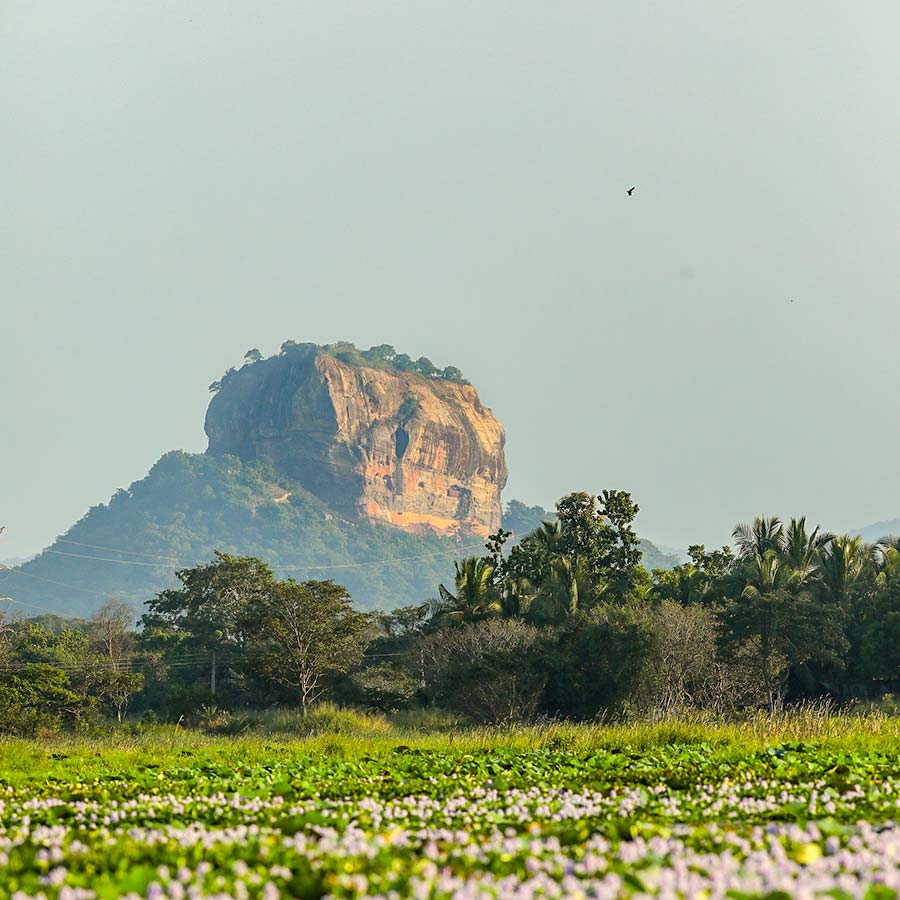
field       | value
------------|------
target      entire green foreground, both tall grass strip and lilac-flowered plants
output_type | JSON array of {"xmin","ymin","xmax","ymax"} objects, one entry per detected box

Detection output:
[{"xmin": 0, "ymin": 709, "xmax": 900, "ymax": 900}]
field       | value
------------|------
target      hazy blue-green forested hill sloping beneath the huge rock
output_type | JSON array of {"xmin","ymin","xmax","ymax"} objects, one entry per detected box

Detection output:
[{"xmin": 0, "ymin": 452, "xmax": 671, "ymax": 616}]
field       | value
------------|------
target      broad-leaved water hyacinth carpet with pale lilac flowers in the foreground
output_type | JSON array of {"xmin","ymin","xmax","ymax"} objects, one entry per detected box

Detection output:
[{"xmin": 0, "ymin": 754, "xmax": 900, "ymax": 900}]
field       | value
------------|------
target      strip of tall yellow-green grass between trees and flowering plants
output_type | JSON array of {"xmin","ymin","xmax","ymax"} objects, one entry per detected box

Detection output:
[{"xmin": 0, "ymin": 704, "xmax": 900, "ymax": 784}]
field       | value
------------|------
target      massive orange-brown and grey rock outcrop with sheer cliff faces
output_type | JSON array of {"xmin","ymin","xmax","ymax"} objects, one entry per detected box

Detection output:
[{"xmin": 206, "ymin": 348, "xmax": 506, "ymax": 535}]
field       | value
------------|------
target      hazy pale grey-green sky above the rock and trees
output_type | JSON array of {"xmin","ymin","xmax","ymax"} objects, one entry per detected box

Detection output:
[{"xmin": 0, "ymin": 0, "xmax": 900, "ymax": 557}]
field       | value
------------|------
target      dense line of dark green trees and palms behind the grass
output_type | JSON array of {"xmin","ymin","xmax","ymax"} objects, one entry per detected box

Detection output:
[{"xmin": 0, "ymin": 491, "xmax": 900, "ymax": 730}]
